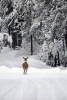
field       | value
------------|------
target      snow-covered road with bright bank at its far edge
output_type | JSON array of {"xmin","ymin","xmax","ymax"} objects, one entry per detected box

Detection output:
[{"xmin": 0, "ymin": 66, "xmax": 67, "ymax": 100}]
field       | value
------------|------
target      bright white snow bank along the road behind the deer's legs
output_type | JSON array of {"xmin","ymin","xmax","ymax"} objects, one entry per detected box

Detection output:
[{"xmin": 0, "ymin": 66, "xmax": 67, "ymax": 75}]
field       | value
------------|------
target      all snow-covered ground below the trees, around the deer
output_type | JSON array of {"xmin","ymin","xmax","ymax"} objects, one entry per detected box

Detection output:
[{"xmin": 0, "ymin": 48, "xmax": 67, "ymax": 100}]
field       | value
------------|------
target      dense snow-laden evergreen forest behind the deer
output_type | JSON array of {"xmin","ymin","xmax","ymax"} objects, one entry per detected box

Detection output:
[{"xmin": 0, "ymin": 0, "xmax": 67, "ymax": 67}]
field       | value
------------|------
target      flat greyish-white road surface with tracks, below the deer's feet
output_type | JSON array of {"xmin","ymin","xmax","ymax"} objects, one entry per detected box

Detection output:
[{"xmin": 0, "ymin": 75, "xmax": 67, "ymax": 100}]
